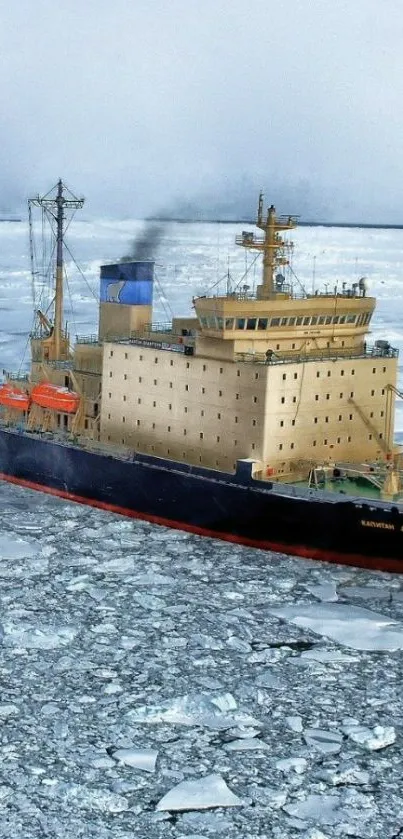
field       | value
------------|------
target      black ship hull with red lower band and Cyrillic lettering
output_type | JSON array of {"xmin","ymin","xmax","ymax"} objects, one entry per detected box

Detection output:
[{"xmin": 0, "ymin": 429, "xmax": 403, "ymax": 572}]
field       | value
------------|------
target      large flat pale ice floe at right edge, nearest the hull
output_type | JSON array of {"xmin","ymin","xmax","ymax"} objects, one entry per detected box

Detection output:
[{"xmin": 269, "ymin": 603, "xmax": 403, "ymax": 651}]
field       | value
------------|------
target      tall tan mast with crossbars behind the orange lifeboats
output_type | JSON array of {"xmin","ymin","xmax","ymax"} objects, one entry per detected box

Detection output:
[{"xmin": 28, "ymin": 179, "xmax": 84, "ymax": 361}]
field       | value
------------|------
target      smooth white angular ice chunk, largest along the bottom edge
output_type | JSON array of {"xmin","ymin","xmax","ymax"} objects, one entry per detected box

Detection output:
[{"xmin": 157, "ymin": 774, "xmax": 244, "ymax": 811}]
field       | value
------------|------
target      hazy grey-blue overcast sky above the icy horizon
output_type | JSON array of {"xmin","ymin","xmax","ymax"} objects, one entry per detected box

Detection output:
[{"xmin": 0, "ymin": 0, "xmax": 403, "ymax": 222}]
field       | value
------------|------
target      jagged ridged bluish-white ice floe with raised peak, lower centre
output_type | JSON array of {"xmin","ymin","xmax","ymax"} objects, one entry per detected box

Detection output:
[{"xmin": 127, "ymin": 693, "xmax": 260, "ymax": 729}]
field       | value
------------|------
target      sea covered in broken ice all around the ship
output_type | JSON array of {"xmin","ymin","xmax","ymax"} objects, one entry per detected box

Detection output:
[{"xmin": 0, "ymin": 221, "xmax": 403, "ymax": 839}]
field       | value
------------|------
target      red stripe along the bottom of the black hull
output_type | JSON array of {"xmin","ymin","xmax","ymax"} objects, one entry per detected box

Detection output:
[{"xmin": 0, "ymin": 472, "xmax": 403, "ymax": 574}]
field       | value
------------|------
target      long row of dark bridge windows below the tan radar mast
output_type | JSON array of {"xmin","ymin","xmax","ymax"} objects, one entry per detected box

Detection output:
[{"xmin": 200, "ymin": 312, "xmax": 371, "ymax": 330}]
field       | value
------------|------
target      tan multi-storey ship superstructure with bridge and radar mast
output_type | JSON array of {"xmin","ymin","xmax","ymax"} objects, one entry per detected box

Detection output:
[{"xmin": 15, "ymin": 191, "xmax": 397, "ymax": 488}]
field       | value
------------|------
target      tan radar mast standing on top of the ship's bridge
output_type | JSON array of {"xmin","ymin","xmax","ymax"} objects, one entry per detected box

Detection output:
[{"xmin": 236, "ymin": 192, "xmax": 297, "ymax": 300}]
